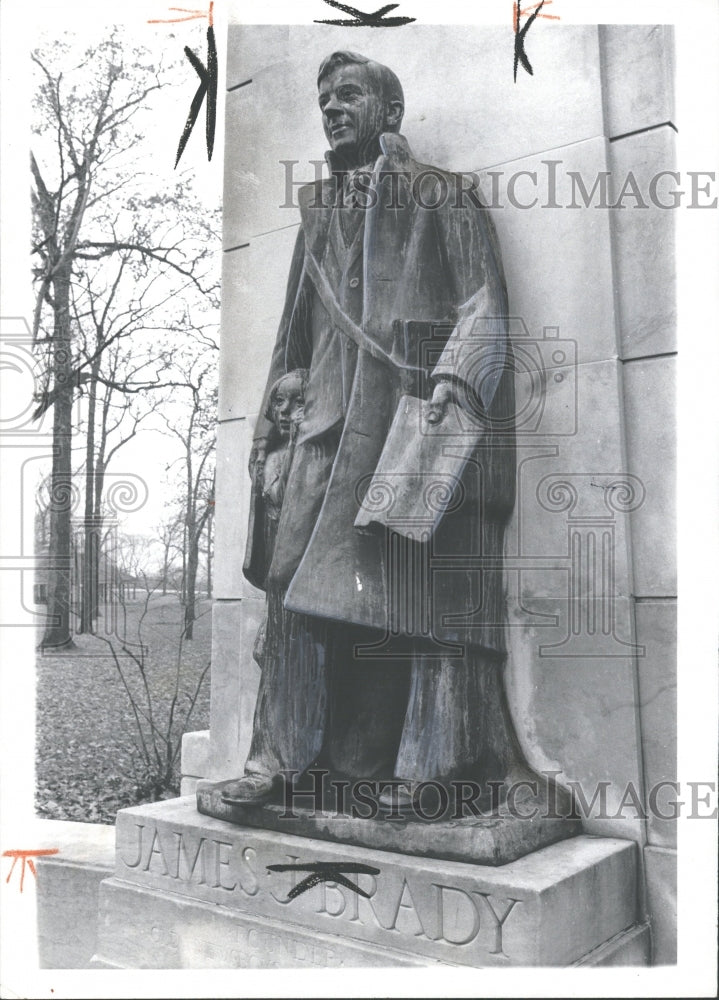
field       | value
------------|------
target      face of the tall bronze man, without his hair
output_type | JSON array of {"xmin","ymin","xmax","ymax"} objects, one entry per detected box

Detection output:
[{"xmin": 319, "ymin": 65, "xmax": 385, "ymax": 164}]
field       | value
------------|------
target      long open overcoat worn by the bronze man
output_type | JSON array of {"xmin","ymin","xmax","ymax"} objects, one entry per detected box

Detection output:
[{"xmin": 245, "ymin": 133, "xmax": 515, "ymax": 654}]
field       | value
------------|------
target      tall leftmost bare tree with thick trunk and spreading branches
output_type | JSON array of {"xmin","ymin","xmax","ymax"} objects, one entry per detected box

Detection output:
[{"xmin": 31, "ymin": 34, "xmax": 219, "ymax": 647}]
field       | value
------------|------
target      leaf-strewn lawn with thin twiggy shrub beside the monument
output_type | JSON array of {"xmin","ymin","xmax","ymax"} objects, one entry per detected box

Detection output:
[{"xmin": 35, "ymin": 590, "xmax": 211, "ymax": 823}]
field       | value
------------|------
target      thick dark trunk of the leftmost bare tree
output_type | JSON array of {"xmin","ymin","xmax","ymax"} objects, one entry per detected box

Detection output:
[{"xmin": 41, "ymin": 265, "xmax": 73, "ymax": 649}]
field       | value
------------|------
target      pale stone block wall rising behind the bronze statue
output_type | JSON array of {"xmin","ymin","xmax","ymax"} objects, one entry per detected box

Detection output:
[{"xmin": 183, "ymin": 22, "xmax": 677, "ymax": 963}]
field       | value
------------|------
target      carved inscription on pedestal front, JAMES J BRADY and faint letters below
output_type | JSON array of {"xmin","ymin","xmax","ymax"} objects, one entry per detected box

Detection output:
[{"xmin": 118, "ymin": 823, "xmax": 522, "ymax": 964}]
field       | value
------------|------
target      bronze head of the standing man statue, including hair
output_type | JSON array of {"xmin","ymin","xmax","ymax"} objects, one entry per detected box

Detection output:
[{"xmin": 317, "ymin": 52, "xmax": 404, "ymax": 167}]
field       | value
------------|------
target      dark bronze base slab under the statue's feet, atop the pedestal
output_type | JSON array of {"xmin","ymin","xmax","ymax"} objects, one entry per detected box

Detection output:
[{"xmin": 197, "ymin": 781, "xmax": 582, "ymax": 865}]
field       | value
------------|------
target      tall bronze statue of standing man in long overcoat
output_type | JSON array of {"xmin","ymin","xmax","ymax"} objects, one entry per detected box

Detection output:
[{"xmin": 223, "ymin": 52, "xmax": 523, "ymax": 805}]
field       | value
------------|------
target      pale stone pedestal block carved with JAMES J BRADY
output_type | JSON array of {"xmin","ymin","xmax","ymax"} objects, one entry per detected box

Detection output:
[{"xmin": 94, "ymin": 797, "xmax": 648, "ymax": 969}]
